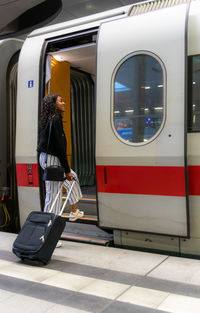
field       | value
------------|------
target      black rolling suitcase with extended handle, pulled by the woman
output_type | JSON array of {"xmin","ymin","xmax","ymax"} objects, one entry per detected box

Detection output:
[{"xmin": 13, "ymin": 182, "xmax": 74, "ymax": 265}]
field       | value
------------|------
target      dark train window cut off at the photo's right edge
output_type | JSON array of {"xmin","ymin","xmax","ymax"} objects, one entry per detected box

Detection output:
[{"xmin": 188, "ymin": 55, "xmax": 200, "ymax": 132}]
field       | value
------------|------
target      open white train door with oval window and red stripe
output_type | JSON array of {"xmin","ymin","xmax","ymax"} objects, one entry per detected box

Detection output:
[{"xmin": 96, "ymin": 4, "xmax": 189, "ymax": 237}]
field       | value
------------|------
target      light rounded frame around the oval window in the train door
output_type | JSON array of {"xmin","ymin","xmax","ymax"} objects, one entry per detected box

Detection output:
[{"xmin": 110, "ymin": 50, "xmax": 167, "ymax": 147}]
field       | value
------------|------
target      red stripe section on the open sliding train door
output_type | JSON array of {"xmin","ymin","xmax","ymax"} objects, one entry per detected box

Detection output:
[{"xmin": 97, "ymin": 165, "xmax": 185, "ymax": 197}]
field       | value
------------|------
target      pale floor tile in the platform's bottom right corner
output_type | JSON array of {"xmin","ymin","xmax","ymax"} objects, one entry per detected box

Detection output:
[{"xmin": 158, "ymin": 295, "xmax": 200, "ymax": 313}]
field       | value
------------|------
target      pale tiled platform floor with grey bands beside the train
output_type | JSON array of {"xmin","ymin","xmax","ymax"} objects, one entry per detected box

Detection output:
[{"xmin": 0, "ymin": 232, "xmax": 200, "ymax": 313}]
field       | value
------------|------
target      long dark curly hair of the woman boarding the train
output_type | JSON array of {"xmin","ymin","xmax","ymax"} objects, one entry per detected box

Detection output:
[{"xmin": 40, "ymin": 94, "xmax": 60, "ymax": 127}]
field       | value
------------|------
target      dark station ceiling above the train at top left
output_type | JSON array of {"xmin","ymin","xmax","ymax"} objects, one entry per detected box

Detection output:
[{"xmin": 0, "ymin": 0, "xmax": 141, "ymax": 38}]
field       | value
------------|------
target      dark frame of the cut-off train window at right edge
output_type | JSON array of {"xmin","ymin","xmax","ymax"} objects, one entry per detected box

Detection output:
[{"xmin": 187, "ymin": 54, "xmax": 200, "ymax": 133}]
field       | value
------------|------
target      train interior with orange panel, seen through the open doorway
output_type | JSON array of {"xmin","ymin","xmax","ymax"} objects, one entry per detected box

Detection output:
[{"xmin": 45, "ymin": 32, "xmax": 112, "ymax": 244}]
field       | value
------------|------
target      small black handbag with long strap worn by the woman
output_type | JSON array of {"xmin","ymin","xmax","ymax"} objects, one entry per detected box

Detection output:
[{"xmin": 43, "ymin": 118, "xmax": 66, "ymax": 181}]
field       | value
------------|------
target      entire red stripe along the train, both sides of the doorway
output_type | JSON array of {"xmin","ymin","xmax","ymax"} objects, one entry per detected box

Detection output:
[{"xmin": 16, "ymin": 163, "xmax": 200, "ymax": 197}]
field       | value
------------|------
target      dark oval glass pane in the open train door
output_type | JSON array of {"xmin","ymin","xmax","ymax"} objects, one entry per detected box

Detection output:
[{"xmin": 113, "ymin": 54, "xmax": 164, "ymax": 144}]
